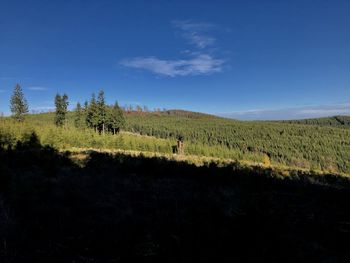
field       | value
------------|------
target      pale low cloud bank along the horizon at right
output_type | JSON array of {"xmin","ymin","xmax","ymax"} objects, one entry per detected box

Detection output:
[{"xmin": 218, "ymin": 103, "xmax": 350, "ymax": 120}]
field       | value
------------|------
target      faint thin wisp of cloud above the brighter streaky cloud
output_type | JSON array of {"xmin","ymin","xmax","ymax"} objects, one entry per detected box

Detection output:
[{"xmin": 172, "ymin": 20, "xmax": 216, "ymax": 49}]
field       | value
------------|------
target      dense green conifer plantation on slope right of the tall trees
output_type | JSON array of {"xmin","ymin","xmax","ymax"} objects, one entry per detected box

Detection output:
[{"xmin": 126, "ymin": 114, "xmax": 350, "ymax": 172}]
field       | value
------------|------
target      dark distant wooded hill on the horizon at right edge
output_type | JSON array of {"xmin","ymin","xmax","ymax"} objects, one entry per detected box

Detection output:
[{"xmin": 281, "ymin": 116, "xmax": 350, "ymax": 128}]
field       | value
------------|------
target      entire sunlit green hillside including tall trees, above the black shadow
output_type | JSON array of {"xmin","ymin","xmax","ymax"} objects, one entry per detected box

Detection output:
[{"xmin": 0, "ymin": 85, "xmax": 350, "ymax": 174}]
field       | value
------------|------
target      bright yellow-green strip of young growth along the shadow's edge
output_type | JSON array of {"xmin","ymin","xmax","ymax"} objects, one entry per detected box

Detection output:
[{"xmin": 0, "ymin": 113, "xmax": 264, "ymax": 166}]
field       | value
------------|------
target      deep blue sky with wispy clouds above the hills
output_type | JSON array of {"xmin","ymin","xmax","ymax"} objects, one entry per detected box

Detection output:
[{"xmin": 0, "ymin": 0, "xmax": 350, "ymax": 119}]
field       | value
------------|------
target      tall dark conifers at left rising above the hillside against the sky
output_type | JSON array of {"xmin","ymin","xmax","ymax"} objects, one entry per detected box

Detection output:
[{"xmin": 10, "ymin": 84, "xmax": 125, "ymax": 134}]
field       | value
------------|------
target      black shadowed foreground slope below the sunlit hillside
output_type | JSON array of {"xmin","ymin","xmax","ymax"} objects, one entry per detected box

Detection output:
[{"xmin": 0, "ymin": 134, "xmax": 350, "ymax": 263}]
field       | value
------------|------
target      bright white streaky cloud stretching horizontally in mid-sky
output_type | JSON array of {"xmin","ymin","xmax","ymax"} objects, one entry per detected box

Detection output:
[{"xmin": 120, "ymin": 54, "xmax": 224, "ymax": 77}]
